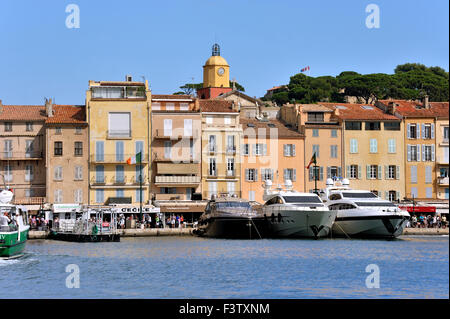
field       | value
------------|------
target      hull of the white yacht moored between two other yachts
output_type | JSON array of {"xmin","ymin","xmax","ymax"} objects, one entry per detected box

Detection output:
[{"xmin": 267, "ymin": 210, "xmax": 336, "ymax": 238}]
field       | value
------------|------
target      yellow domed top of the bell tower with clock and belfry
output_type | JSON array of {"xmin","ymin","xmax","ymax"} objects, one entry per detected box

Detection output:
[{"xmin": 203, "ymin": 43, "xmax": 230, "ymax": 88}]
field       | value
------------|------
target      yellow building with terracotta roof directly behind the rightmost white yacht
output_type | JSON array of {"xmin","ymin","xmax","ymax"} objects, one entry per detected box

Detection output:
[{"xmin": 323, "ymin": 103, "xmax": 405, "ymax": 201}]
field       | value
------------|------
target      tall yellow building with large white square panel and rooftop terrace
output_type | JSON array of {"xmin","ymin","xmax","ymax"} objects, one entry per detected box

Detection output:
[{"xmin": 86, "ymin": 76, "xmax": 151, "ymax": 205}]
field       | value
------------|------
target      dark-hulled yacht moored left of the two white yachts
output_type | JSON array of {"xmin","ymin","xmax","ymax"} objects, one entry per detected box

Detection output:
[{"xmin": 195, "ymin": 196, "xmax": 266, "ymax": 239}]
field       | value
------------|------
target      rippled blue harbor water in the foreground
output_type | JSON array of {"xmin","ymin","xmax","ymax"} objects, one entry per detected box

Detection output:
[{"xmin": 0, "ymin": 236, "xmax": 449, "ymax": 299}]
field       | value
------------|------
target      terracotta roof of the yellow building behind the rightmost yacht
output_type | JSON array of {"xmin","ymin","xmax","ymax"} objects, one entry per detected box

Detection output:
[{"xmin": 320, "ymin": 102, "xmax": 400, "ymax": 121}]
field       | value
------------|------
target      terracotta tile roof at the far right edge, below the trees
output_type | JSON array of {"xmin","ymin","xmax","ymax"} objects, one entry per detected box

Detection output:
[{"xmin": 379, "ymin": 100, "xmax": 449, "ymax": 118}]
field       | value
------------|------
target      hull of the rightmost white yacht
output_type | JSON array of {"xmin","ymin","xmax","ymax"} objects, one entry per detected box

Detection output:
[{"xmin": 332, "ymin": 214, "xmax": 409, "ymax": 238}]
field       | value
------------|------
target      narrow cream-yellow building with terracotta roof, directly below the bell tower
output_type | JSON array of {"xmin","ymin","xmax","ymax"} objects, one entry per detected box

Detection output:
[{"xmin": 199, "ymin": 100, "xmax": 242, "ymax": 199}]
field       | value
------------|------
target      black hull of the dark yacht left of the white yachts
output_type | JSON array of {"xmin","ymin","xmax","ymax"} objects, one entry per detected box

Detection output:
[{"xmin": 196, "ymin": 216, "xmax": 267, "ymax": 239}]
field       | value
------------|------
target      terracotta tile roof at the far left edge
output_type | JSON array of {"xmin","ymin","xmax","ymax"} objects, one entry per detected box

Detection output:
[{"xmin": 0, "ymin": 105, "xmax": 46, "ymax": 121}]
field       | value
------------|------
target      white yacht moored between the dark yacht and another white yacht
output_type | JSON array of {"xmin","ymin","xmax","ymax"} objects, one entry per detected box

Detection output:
[{"xmin": 261, "ymin": 180, "xmax": 336, "ymax": 238}]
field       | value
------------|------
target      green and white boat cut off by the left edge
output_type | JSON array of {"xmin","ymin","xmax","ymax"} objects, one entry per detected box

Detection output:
[{"xmin": 0, "ymin": 190, "xmax": 30, "ymax": 259}]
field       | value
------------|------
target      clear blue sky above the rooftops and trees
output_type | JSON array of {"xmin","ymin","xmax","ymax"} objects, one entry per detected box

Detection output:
[{"xmin": 0, "ymin": 0, "xmax": 449, "ymax": 104}]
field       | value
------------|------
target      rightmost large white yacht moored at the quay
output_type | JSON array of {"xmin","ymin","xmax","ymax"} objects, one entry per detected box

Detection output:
[{"xmin": 320, "ymin": 178, "xmax": 410, "ymax": 238}]
